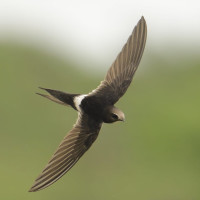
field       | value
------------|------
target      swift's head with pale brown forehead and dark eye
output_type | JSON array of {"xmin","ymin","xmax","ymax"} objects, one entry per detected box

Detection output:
[{"xmin": 104, "ymin": 106, "xmax": 125, "ymax": 123}]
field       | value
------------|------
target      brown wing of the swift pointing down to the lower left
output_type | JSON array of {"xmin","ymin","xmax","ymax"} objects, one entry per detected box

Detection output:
[{"xmin": 29, "ymin": 113, "xmax": 102, "ymax": 192}]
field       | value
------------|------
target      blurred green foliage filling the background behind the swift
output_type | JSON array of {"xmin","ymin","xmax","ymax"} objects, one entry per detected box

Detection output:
[{"xmin": 0, "ymin": 41, "xmax": 200, "ymax": 200}]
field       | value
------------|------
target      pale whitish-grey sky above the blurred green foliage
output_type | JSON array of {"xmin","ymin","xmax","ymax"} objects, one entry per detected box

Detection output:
[{"xmin": 0, "ymin": 0, "xmax": 200, "ymax": 65}]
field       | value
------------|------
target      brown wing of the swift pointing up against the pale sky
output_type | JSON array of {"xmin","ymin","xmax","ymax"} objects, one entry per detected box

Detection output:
[{"xmin": 90, "ymin": 17, "xmax": 147, "ymax": 104}]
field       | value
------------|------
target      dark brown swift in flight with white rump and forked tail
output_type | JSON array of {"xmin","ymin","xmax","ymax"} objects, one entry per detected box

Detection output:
[{"xmin": 29, "ymin": 16, "xmax": 147, "ymax": 192}]
